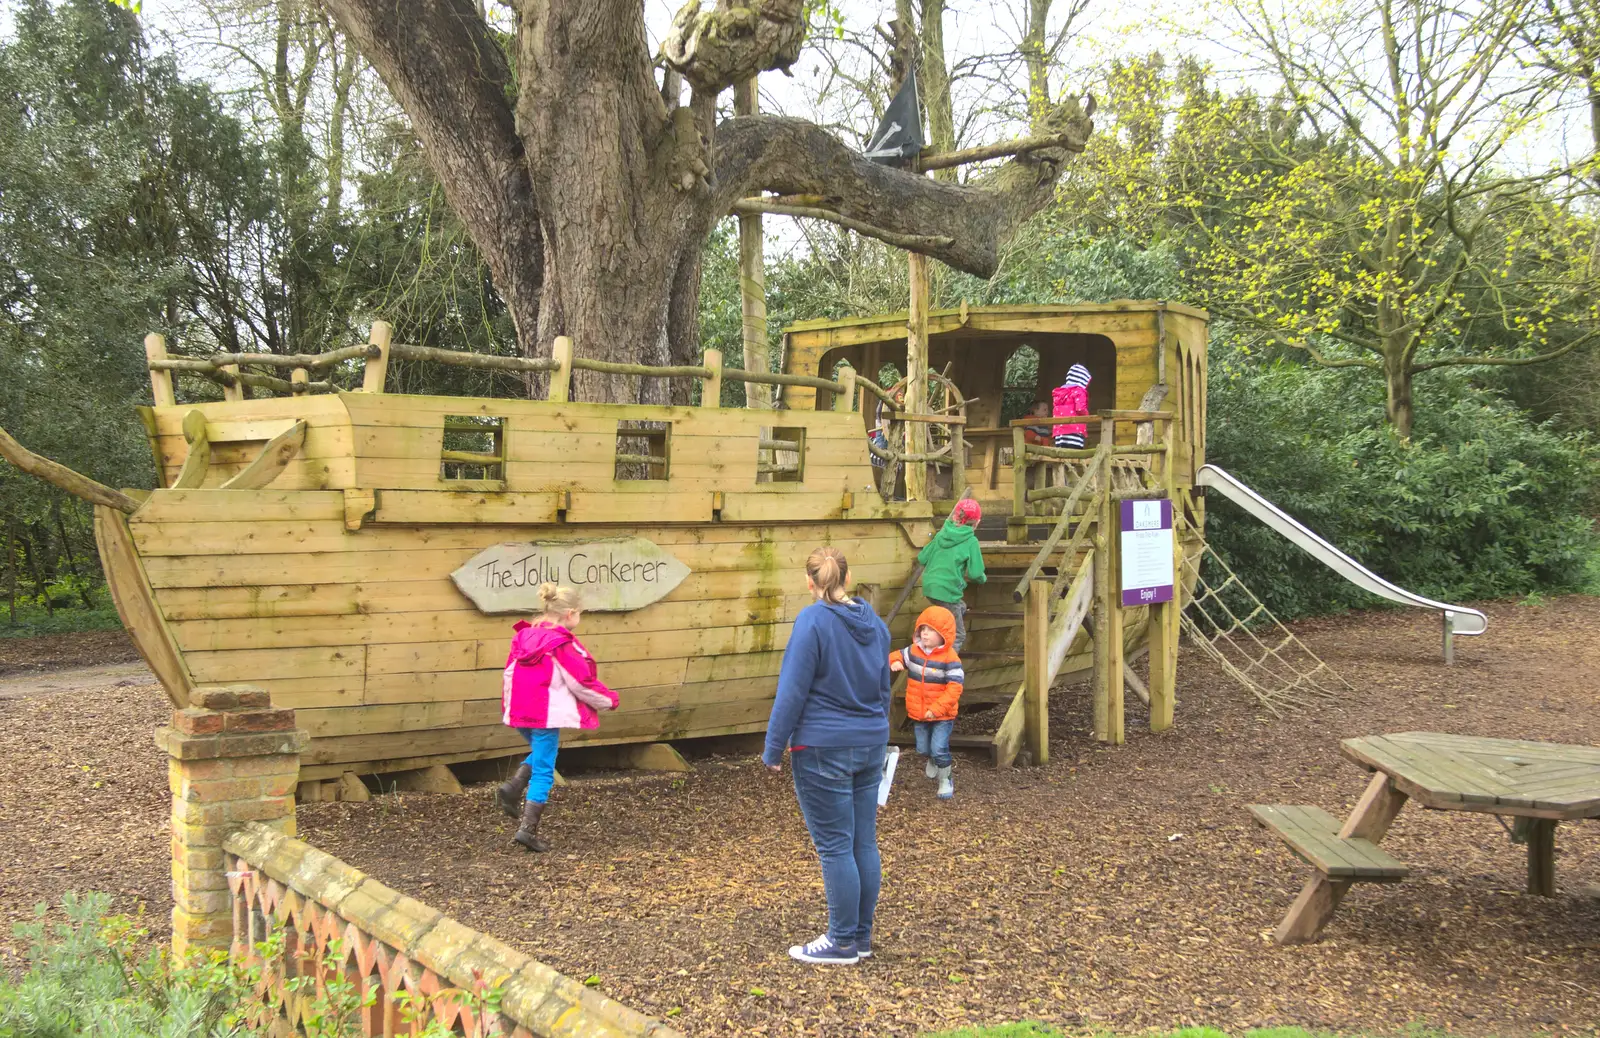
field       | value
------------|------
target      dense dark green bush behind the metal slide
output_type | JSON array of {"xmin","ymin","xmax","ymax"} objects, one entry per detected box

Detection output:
[{"xmin": 1206, "ymin": 329, "xmax": 1600, "ymax": 617}]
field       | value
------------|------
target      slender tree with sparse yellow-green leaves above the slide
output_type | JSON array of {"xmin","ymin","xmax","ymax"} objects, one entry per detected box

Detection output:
[{"xmin": 1176, "ymin": 0, "xmax": 1600, "ymax": 437}]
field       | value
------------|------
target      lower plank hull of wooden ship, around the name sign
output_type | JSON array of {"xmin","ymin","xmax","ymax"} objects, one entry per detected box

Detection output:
[{"xmin": 130, "ymin": 489, "xmax": 915, "ymax": 779}]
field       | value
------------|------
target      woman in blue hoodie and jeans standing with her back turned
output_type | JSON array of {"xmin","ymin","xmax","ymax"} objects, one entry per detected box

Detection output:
[{"xmin": 762, "ymin": 547, "xmax": 890, "ymax": 964}]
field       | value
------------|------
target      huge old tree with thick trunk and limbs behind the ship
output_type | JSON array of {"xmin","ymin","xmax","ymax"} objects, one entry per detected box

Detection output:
[{"xmin": 326, "ymin": 0, "xmax": 1091, "ymax": 401}]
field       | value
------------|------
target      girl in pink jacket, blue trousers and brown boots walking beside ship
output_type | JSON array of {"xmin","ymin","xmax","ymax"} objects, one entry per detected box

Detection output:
[{"xmin": 494, "ymin": 584, "xmax": 618, "ymax": 851}]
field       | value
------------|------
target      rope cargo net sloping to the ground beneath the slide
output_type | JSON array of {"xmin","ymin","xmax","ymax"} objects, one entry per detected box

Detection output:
[{"xmin": 1179, "ymin": 545, "xmax": 1354, "ymax": 717}]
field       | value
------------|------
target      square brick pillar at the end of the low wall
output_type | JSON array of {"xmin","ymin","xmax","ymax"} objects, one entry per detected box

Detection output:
[{"xmin": 155, "ymin": 685, "xmax": 307, "ymax": 958}]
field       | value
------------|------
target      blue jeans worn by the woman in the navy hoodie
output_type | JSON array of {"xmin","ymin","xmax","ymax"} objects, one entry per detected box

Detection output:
[{"xmin": 789, "ymin": 745, "xmax": 888, "ymax": 947}]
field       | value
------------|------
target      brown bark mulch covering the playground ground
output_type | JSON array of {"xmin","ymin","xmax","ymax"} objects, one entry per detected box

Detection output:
[{"xmin": 0, "ymin": 598, "xmax": 1600, "ymax": 1038}]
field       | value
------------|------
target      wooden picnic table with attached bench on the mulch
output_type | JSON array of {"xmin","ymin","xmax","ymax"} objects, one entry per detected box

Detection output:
[{"xmin": 1250, "ymin": 731, "xmax": 1600, "ymax": 944}]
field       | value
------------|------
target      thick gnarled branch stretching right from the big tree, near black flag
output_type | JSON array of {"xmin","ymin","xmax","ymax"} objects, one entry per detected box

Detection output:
[{"xmin": 714, "ymin": 101, "xmax": 1093, "ymax": 277}]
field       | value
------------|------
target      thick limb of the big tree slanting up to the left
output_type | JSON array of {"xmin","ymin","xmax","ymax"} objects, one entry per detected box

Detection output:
[{"xmin": 326, "ymin": 0, "xmax": 544, "ymax": 349}]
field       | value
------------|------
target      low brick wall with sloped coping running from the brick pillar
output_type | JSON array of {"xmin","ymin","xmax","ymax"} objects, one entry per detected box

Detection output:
[{"xmin": 222, "ymin": 824, "xmax": 682, "ymax": 1038}]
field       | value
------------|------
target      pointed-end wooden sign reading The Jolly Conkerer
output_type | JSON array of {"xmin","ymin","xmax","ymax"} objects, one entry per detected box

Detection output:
[{"xmin": 450, "ymin": 537, "xmax": 690, "ymax": 613}]
